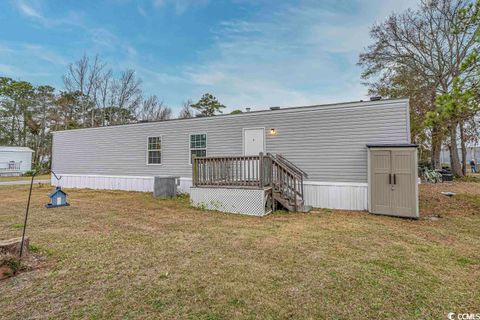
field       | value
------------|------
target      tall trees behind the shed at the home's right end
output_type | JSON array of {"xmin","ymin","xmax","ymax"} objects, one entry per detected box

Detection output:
[{"xmin": 359, "ymin": 0, "xmax": 480, "ymax": 176}]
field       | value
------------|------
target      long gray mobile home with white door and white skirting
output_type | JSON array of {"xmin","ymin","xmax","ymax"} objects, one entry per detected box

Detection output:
[{"xmin": 52, "ymin": 99, "xmax": 416, "ymax": 218}]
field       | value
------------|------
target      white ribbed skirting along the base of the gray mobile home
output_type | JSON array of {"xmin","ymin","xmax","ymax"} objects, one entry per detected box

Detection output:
[{"xmin": 51, "ymin": 174, "xmax": 368, "ymax": 210}]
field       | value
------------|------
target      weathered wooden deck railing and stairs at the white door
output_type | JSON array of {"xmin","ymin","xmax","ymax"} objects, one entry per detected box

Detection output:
[{"xmin": 192, "ymin": 153, "xmax": 310, "ymax": 212}]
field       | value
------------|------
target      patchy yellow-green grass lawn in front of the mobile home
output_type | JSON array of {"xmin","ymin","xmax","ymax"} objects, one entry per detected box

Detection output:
[{"xmin": 0, "ymin": 182, "xmax": 480, "ymax": 319}]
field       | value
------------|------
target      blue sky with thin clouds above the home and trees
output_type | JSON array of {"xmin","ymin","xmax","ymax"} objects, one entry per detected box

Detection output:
[{"xmin": 0, "ymin": 0, "xmax": 416, "ymax": 110}]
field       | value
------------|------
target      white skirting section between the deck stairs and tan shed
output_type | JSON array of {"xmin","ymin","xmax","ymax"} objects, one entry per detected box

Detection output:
[{"xmin": 304, "ymin": 181, "xmax": 368, "ymax": 210}]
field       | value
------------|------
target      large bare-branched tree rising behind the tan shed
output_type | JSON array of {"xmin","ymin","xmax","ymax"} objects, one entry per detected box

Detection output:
[{"xmin": 359, "ymin": 0, "xmax": 479, "ymax": 173}]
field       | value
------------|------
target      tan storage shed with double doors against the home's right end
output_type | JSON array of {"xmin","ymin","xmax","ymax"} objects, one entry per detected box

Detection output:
[{"xmin": 367, "ymin": 144, "xmax": 419, "ymax": 219}]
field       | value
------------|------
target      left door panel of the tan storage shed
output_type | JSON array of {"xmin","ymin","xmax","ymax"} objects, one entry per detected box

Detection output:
[{"xmin": 371, "ymin": 150, "xmax": 392, "ymax": 214}]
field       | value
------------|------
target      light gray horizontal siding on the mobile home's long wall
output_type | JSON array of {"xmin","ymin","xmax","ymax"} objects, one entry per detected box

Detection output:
[{"xmin": 52, "ymin": 99, "xmax": 410, "ymax": 183}]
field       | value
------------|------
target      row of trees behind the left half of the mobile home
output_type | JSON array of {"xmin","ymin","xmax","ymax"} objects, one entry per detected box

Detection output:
[{"xmin": 0, "ymin": 55, "xmax": 229, "ymax": 169}]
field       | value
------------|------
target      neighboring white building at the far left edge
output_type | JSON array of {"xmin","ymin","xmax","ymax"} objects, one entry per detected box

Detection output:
[{"xmin": 0, "ymin": 146, "xmax": 33, "ymax": 176}]
